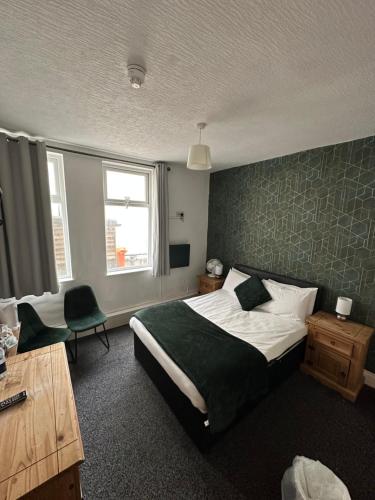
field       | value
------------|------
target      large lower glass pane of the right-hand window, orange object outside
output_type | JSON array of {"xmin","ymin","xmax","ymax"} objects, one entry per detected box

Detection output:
[{"xmin": 105, "ymin": 205, "xmax": 149, "ymax": 271}]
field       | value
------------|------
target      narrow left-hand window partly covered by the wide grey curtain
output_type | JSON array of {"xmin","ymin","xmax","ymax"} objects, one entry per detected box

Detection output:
[{"xmin": 47, "ymin": 151, "xmax": 72, "ymax": 281}]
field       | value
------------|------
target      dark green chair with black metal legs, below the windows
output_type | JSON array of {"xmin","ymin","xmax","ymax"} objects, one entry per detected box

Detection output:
[{"xmin": 64, "ymin": 285, "xmax": 109, "ymax": 361}]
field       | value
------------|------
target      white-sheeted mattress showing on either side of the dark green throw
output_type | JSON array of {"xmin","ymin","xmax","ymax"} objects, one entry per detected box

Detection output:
[{"xmin": 130, "ymin": 289, "xmax": 307, "ymax": 413}]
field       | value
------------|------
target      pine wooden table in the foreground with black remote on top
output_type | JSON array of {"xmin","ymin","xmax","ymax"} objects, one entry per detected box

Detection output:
[{"xmin": 0, "ymin": 343, "xmax": 84, "ymax": 500}]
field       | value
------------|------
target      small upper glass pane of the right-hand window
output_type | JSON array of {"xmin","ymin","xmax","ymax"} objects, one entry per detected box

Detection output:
[{"xmin": 106, "ymin": 170, "xmax": 148, "ymax": 201}]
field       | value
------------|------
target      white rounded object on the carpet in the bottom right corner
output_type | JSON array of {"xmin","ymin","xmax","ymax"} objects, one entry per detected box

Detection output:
[{"xmin": 281, "ymin": 455, "xmax": 350, "ymax": 500}]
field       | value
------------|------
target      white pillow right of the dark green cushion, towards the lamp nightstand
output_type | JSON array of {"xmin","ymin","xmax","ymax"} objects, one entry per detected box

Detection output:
[{"xmin": 254, "ymin": 280, "xmax": 310, "ymax": 321}]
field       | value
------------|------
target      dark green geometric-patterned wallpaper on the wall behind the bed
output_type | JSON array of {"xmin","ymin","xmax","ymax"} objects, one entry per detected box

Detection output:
[{"xmin": 207, "ymin": 137, "xmax": 375, "ymax": 370}]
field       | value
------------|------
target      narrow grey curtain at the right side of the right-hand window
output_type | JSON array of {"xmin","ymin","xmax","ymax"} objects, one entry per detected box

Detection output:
[{"xmin": 152, "ymin": 162, "xmax": 170, "ymax": 276}]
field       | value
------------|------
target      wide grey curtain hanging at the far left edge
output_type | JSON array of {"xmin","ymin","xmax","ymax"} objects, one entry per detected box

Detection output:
[{"xmin": 0, "ymin": 133, "xmax": 58, "ymax": 298}]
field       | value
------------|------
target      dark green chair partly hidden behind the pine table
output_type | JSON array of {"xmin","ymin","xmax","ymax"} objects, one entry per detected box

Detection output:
[{"xmin": 17, "ymin": 302, "xmax": 71, "ymax": 352}]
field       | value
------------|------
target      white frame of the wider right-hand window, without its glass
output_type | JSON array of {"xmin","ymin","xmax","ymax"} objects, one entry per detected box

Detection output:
[{"xmin": 102, "ymin": 161, "xmax": 154, "ymax": 276}]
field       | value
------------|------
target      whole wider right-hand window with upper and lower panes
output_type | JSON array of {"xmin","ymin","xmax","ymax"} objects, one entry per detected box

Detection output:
[{"xmin": 103, "ymin": 162, "xmax": 151, "ymax": 273}]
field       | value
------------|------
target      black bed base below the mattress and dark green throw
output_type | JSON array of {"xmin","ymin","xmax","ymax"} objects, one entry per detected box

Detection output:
[{"xmin": 134, "ymin": 333, "xmax": 305, "ymax": 451}]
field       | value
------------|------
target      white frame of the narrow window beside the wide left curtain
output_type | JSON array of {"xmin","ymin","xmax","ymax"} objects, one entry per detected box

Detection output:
[{"xmin": 47, "ymin": 150, "xmax": 73, "ymax": 283}]
